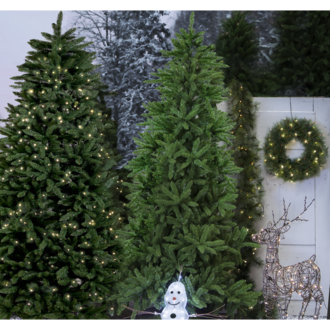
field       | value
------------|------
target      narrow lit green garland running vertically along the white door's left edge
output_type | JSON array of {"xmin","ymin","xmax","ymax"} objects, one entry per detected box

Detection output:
[{"xmin": 227, "ymin": 79, "xmax": 270, "ymax": 320}]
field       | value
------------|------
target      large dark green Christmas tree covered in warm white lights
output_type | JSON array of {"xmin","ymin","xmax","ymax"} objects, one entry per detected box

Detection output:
[{"xmin": 0, "ymin": 11, "xmax": 126, "ymax": 320}]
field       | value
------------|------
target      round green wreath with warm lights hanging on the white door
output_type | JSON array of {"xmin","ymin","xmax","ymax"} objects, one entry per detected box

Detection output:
[{"xmin": 264, "ymin": 118, "xmax": 329, "ymax": 182}]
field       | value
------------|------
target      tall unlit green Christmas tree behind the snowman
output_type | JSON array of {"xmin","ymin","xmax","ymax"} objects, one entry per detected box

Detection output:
[{"xmin": 109, "ymin": 13, "xmax": 261, "ymax": 319}]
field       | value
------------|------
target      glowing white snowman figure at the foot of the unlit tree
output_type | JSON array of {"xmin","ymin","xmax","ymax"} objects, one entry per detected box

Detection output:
[{"xmin": 161, "ymin": 282, "xmax": 189, "ymax": 320}]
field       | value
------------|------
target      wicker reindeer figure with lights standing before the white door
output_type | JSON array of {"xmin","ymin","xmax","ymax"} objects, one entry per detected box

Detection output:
[{"xmin": 252, "ymin": 197, "xmax": 324, "ymax": 320}]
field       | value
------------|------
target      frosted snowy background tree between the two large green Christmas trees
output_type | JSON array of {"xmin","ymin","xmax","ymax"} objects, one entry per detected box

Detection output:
[{"xmin": 67, "ymin": 10, "xmax": 173, "ymax": 169}]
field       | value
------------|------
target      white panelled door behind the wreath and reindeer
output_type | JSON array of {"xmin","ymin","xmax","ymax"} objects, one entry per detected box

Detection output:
[{"xmin": 217, "ymin": 97, "xmax": 330, "ymax": 316}]
